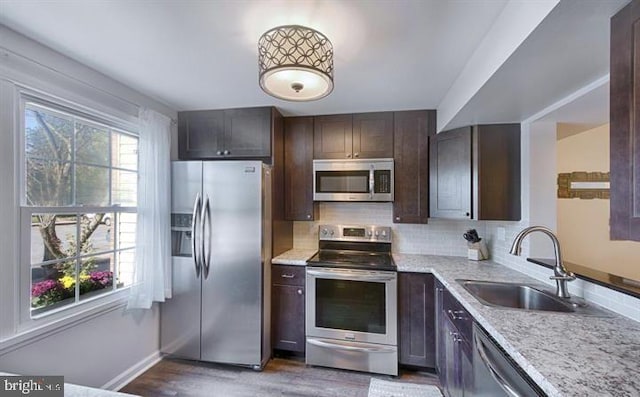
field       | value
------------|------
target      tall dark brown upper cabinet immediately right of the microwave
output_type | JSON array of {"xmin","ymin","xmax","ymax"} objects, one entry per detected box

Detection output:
[{"xmin": 393, "ymin": 110, "xmax": 436, "ymax": 223}]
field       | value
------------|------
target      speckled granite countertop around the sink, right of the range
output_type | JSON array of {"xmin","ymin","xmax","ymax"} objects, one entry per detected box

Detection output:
[{"xmin": 393, "ymin": 254, "xmax": 640, "ymax": 397}]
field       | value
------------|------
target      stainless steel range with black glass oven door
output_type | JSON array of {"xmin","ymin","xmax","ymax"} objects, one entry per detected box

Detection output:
[{"xmin": 305, "ymin": 225, "xmax": 398, "ymax": 375}]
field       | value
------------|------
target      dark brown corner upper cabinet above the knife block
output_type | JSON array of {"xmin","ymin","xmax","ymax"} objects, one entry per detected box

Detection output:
[{"xmin": 429, "ymin": 124, "xmax": 521, "ymax": 221}]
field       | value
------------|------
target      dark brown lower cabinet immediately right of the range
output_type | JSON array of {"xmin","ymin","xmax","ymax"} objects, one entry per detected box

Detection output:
[{"xmin": 398, "ymin": 273, "xmax": 436, "ymax": 368}]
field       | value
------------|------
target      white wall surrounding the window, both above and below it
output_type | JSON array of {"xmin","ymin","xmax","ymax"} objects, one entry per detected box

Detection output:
[{"xmin": 0, "ymin": 25, "xmax": 176, "ymax": 388}]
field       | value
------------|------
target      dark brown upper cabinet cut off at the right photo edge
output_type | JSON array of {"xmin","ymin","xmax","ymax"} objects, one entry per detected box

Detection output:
[{"xmin": 609, "ymin": 0, "xmax": 640, "ymax": 241}]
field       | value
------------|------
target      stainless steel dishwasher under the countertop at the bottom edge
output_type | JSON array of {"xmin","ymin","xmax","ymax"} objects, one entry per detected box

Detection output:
[{"xmin": 472, "ymin": 322, "xmax": 546, "ymax": 397}]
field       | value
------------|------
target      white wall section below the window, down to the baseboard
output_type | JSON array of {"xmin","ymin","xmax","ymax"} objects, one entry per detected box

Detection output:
[{"xmin": 0, "ymin": 306, "xmax": 160, "ymax": 389}]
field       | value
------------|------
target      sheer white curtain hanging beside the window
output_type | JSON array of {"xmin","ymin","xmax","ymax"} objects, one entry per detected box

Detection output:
[{"xmin": 127, "ymin": 108, "xmax": 171, "ymax": 309}]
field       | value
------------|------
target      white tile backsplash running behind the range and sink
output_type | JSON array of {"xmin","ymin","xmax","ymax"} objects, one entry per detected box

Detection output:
[{"xmin": 293, "ymin": 202, "xmax": 640, "ymax": 321}]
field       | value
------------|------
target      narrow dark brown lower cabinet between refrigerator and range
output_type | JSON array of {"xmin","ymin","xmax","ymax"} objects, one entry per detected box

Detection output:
[{"xmin": 271, "ymin": 265, "xmax": 305, "ymax": 353}]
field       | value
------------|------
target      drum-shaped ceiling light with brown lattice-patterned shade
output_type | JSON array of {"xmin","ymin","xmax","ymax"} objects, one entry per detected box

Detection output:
[{"xmin": 258, "ymin": 25, "xmax": 333, "ymax": 101}]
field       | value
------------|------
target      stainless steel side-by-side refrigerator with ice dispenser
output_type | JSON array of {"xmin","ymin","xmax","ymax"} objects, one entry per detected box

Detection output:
[{"xmin": 160, "ymin": 161, "xmax": 271, "ymax": 369}]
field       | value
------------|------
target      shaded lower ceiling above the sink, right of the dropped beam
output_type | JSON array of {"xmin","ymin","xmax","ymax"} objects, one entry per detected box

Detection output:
[{"xmin": 448, "ymin": 0, "xmax": 629, "ymax": 128}]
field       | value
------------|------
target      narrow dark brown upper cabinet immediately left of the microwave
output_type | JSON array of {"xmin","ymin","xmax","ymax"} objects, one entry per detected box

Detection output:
[{"xmin": 284, "ymin": 117, "xmax": 318, "ymax": 221}]
